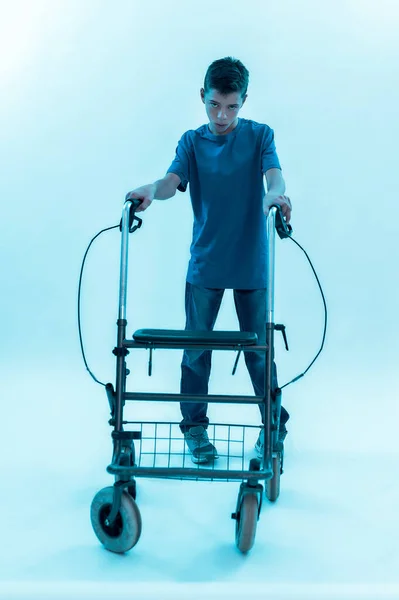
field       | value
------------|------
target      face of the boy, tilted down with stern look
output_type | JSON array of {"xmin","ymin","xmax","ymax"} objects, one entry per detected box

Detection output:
[{"xmin": 200, "ymin": 88, "xmax": 247, "ymax": 135}]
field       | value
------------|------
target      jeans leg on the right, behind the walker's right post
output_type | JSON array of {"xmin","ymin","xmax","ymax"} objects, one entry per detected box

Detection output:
[{"xmin": 234, "ymin": 289, "xmax": 290, "ymax": 427}]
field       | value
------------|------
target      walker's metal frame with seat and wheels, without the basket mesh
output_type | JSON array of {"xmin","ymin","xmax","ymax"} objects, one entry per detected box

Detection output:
[{"xmin": 91, "ymin": 200, "xmax": 292, "ymax": 552}]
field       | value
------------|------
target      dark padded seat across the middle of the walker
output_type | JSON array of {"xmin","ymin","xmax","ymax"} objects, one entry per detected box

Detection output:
[{"xmin": 133, "ymin": 329, "xmax": 258, "ymax": 346}]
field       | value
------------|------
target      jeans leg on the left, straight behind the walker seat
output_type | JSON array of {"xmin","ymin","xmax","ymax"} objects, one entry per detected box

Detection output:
[{"xmin": 180, "ymin": 281, "xmax": 224, "ymax": 432}]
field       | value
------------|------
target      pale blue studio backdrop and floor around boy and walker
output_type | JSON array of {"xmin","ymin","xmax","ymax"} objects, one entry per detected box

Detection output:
[{"xmin": 0, "ymin": 0, "xmax": 399, "ymax": 598}]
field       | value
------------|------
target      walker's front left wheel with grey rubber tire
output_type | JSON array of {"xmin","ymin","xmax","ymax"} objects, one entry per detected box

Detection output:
[{"xmin": 90, "ymin": 486, "xmax": 142, "ymax": 554}]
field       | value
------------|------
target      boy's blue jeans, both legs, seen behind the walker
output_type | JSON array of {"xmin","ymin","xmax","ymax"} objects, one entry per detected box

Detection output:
[{"xmin": 180, "ymin": 281, "xmax": 289, "ymax": 432}]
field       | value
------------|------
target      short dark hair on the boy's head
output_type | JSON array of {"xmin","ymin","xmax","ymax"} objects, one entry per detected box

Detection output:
[{"xmin": 204, "ymin": 56, "xmax": 249, "ymax": 98}]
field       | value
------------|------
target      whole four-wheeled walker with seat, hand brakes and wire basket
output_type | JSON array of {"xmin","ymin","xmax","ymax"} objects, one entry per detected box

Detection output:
[{"xmin": 91, "ymin": 200, "xmax": 292, "ymax": 553}]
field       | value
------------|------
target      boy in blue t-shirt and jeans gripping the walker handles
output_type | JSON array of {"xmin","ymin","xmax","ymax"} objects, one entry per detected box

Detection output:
[{"xmin": 126, "ymin": 57, "xmax": 291, "ymax": 463}]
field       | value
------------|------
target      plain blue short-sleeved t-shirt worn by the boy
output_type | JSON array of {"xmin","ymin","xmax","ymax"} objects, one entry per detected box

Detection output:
[{"xmin": 167, "ymin": 118, "xmax": 281, "ymax": 289}]
